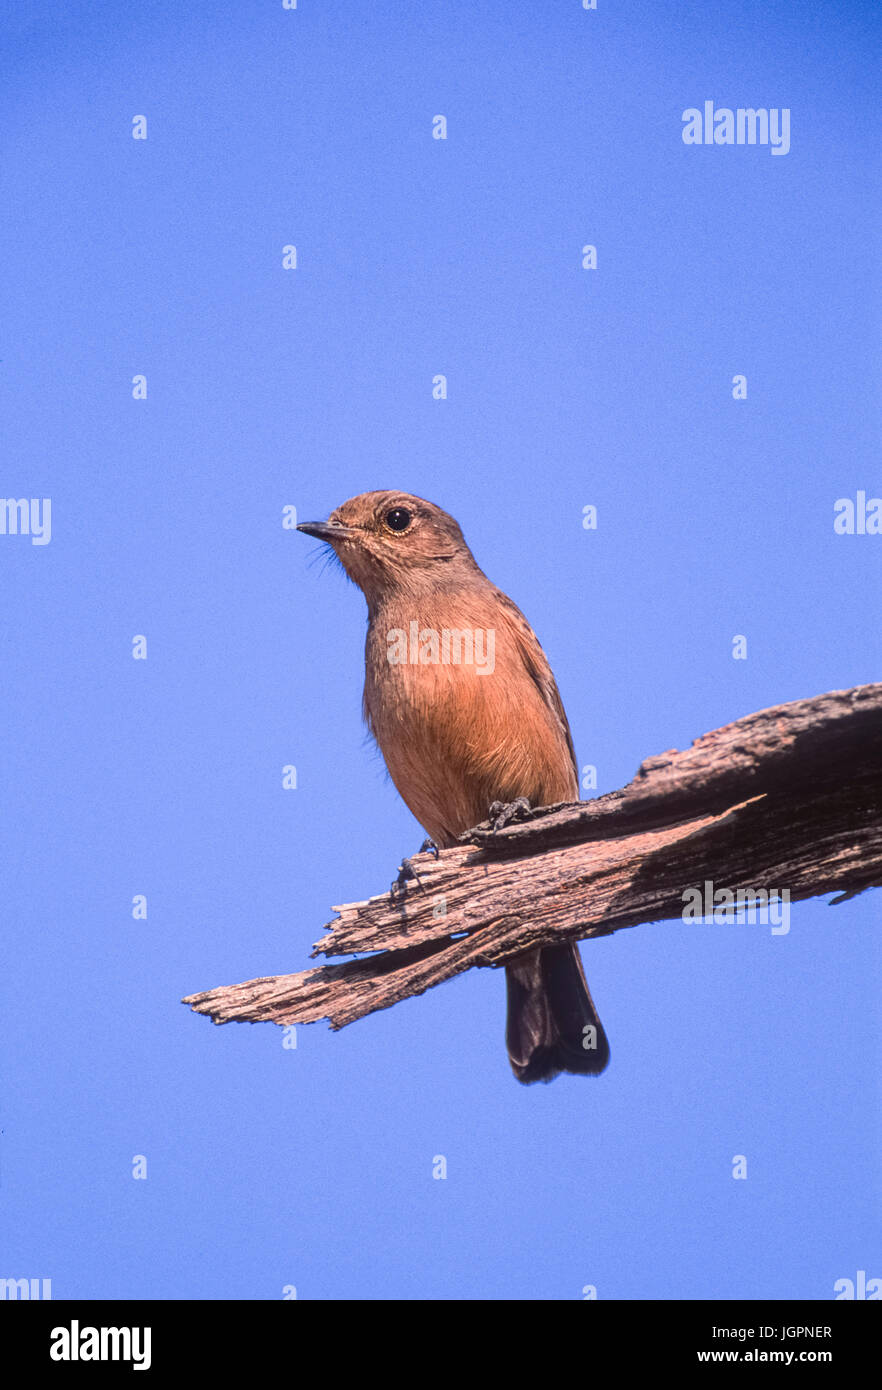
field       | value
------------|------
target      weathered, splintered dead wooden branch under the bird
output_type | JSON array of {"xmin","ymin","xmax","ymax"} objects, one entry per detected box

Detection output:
[{"xmin": 183, "ymin": 684, "xmax": 882, "ymax": 1029}]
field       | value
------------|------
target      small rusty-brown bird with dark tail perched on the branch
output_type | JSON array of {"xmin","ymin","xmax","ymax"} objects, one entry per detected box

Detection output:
[{"xmin": 297, "ymin": 492, "xmax": 610, "ymax": 1083}]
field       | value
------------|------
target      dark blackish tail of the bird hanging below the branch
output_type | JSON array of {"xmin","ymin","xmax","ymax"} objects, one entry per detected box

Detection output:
[{"xmin": 506, "ymin": 941, "xmax": 610, "ymax": 1084}]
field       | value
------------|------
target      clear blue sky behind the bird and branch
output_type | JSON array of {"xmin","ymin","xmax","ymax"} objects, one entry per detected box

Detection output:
[{"xmin": 0, "ymin": 0, "xmax": 882, "ymax": 1300}]
